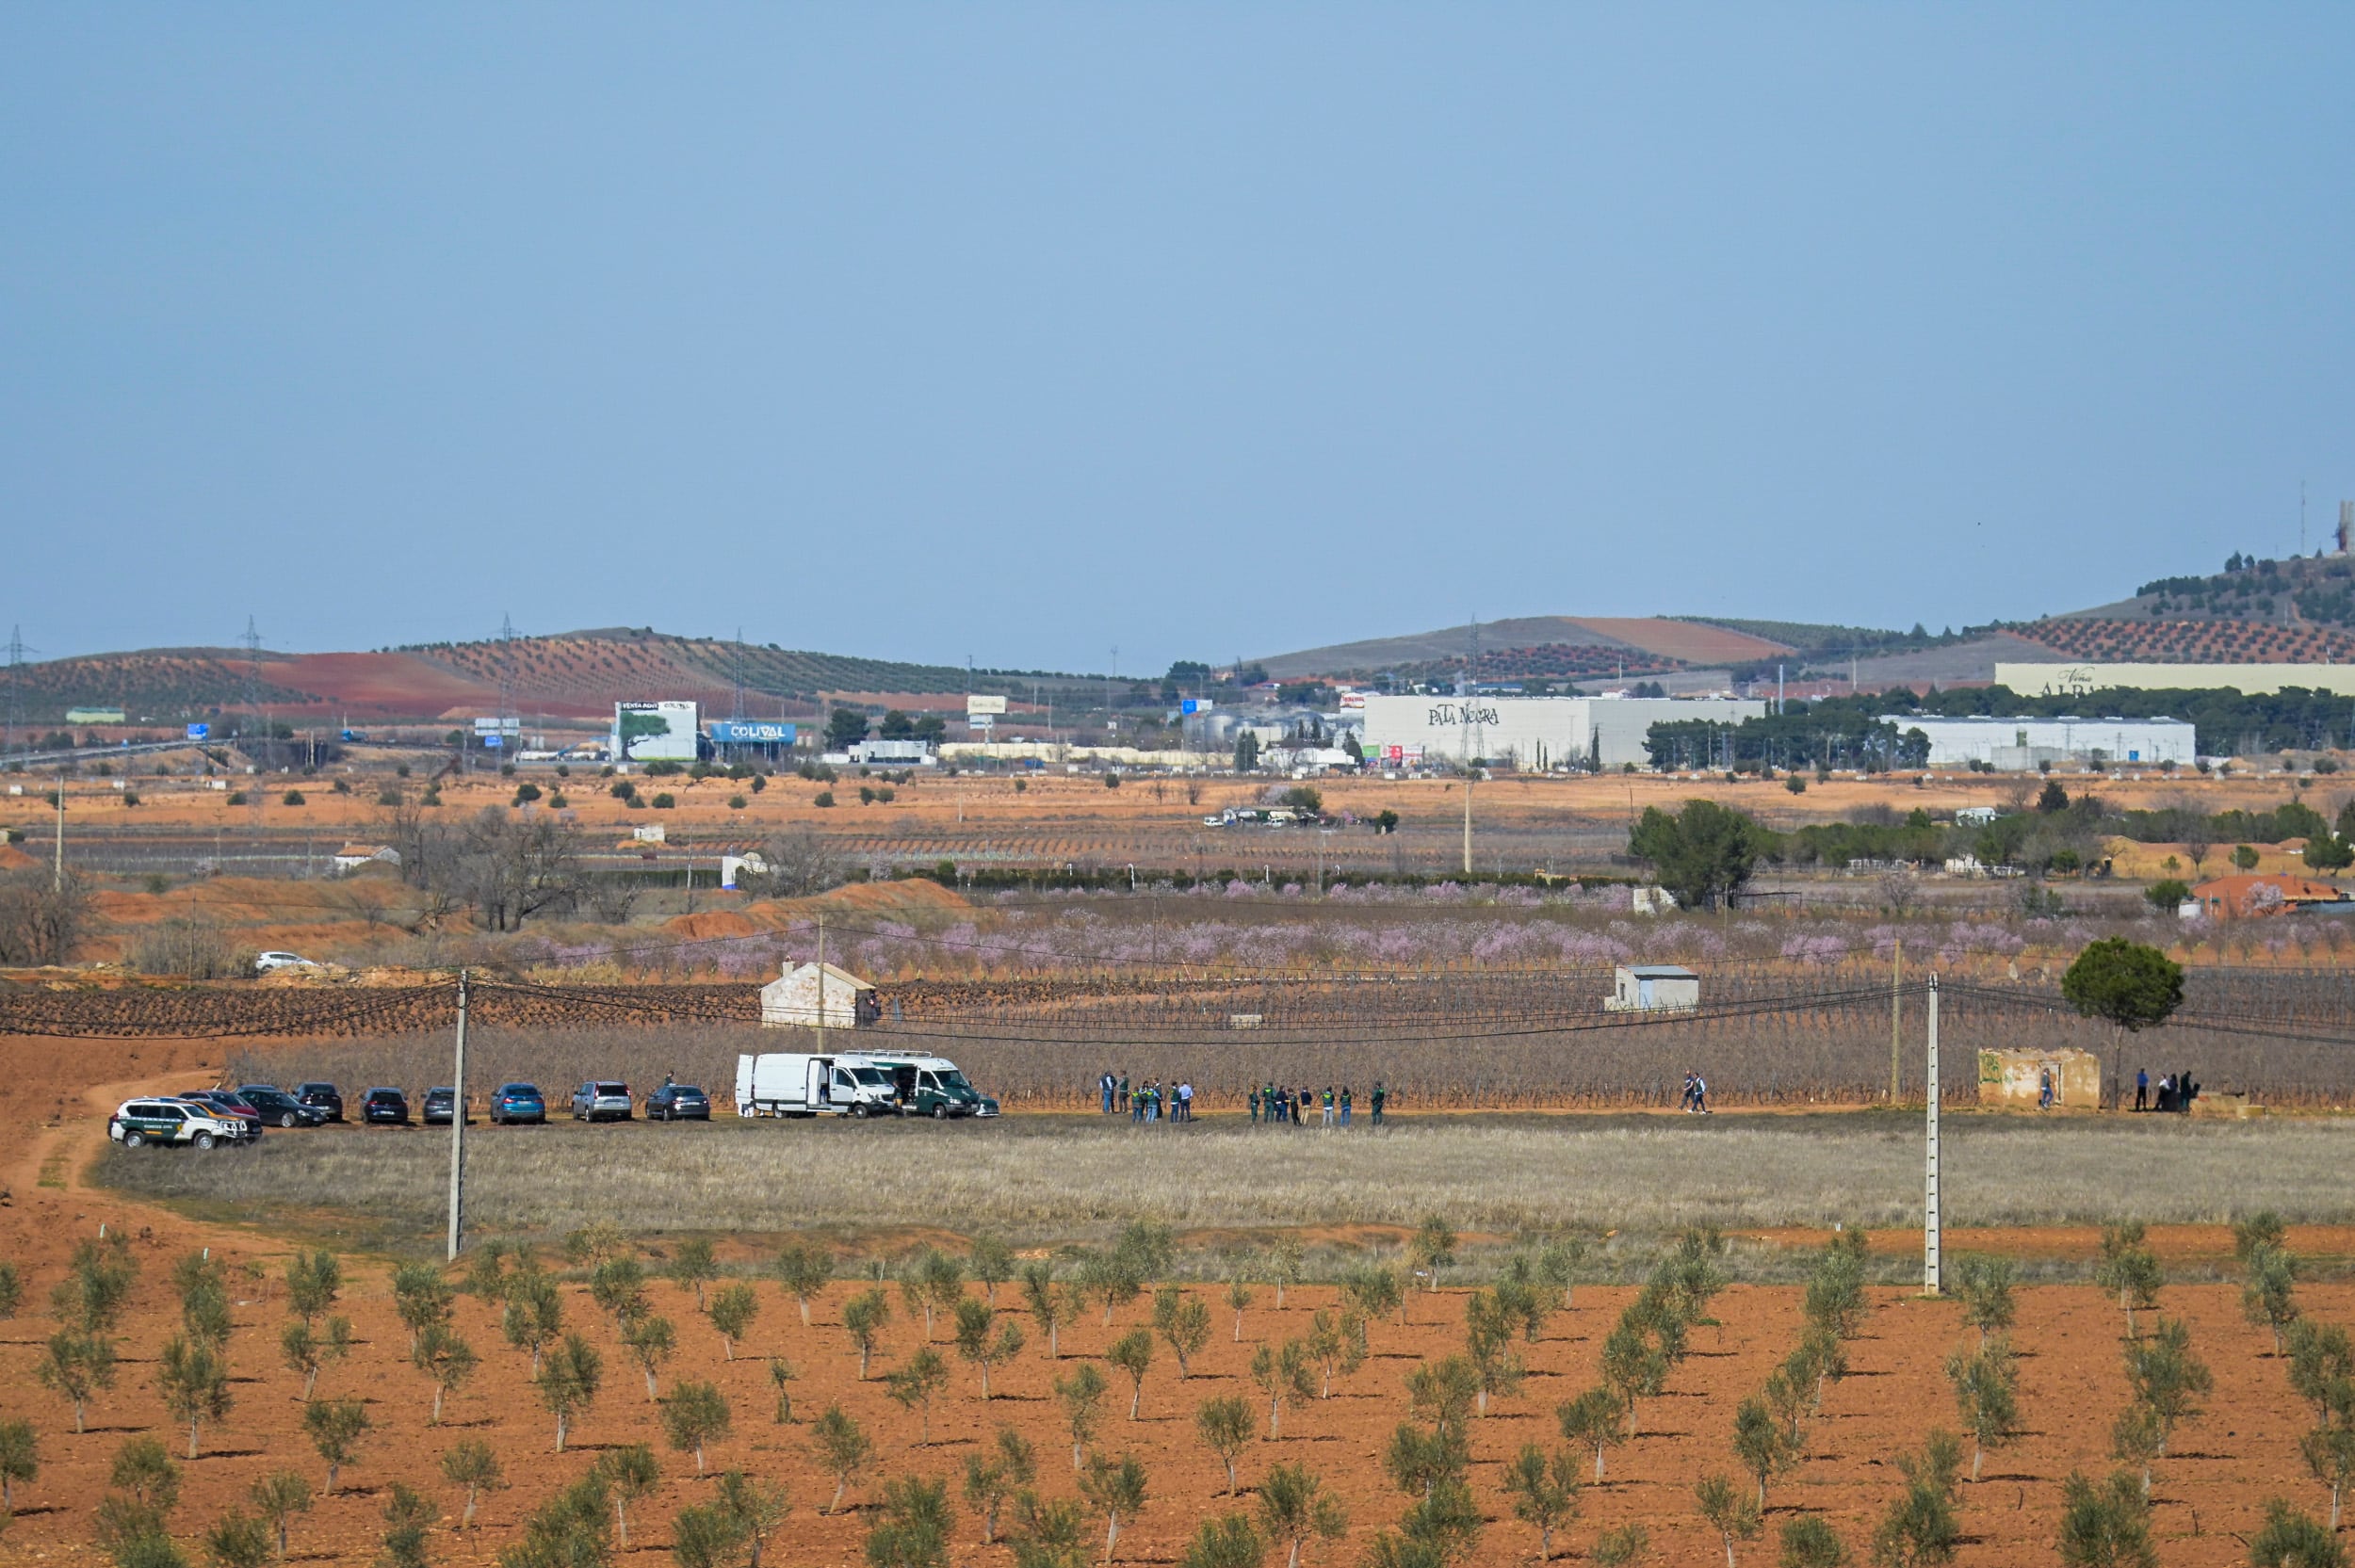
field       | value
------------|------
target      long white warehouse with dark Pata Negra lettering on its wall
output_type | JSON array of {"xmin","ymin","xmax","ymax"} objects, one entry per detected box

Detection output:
[{"xmin": 1364, "ymin": 695, "xmax": 1766, "ymax": 772}]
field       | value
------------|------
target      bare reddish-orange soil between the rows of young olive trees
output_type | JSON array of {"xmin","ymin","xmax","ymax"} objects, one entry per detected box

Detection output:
[{"xmin": 0, "ymin": 1041, "xmax": 2355, "ymax": 1566}]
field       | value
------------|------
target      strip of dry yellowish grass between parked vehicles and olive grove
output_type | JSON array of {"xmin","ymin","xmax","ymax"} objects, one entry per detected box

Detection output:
[{"xmin": 97, "ymin": 1111, "xmax": 2355, "ymax": 1271}]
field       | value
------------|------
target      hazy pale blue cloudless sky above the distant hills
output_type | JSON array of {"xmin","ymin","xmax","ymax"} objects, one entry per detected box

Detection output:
[{"xmin": 0, "ymin": 0, "xmax": 2355, "ymax": 671}]
